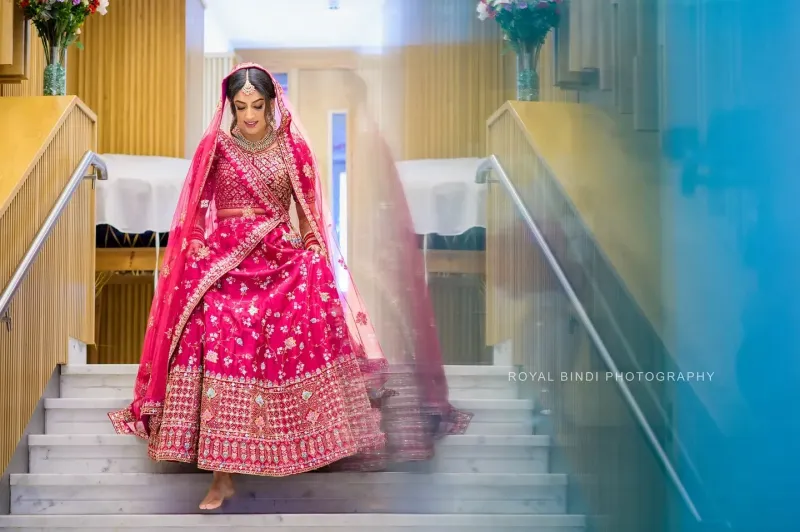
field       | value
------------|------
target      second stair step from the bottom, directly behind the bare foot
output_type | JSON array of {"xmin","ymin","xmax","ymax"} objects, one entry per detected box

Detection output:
[{"xmin": 11, "ymin": 473, "xmax": 567, "ymax": 515}]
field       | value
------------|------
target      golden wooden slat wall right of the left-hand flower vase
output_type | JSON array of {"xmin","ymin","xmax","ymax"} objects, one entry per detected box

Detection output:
[{"xmin": 67, "ymin": 0, "xmax": 194, "ymax": 157}]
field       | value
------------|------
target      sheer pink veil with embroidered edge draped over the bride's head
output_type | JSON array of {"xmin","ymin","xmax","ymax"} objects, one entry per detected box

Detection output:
[{"xmin": 119, "ymin": 63, "xmax": 468, "ymax": 466}]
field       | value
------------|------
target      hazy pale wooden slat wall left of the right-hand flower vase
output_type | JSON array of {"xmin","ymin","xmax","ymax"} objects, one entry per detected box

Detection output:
[{"xmin": 384, "ymin": 0, "xmax": 515, "ymax": 159}]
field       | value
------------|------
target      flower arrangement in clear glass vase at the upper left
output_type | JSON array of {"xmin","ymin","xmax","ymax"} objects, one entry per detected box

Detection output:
[{"xmin": 19, "ymin": 0, "xmax": 109, "ymax": 96}]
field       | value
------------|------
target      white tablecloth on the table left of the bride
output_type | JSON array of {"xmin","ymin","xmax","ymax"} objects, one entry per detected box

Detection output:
[{"xmin": 96, "ymin": 154, "xmax": 191, "ymax": 234}]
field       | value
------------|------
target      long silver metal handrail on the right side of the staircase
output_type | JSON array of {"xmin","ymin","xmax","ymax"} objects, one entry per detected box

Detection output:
[{"xmin": 476, "ymin": 155, "xmax": 703, "ymax": 522}]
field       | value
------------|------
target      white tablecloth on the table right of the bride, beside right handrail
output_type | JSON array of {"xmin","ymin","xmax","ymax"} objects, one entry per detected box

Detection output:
[{"xmin": 396, "ymin": 158, "xmax": 486, "ymax": 236}]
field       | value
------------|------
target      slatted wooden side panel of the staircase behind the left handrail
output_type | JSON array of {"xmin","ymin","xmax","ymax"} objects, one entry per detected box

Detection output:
[{"xmin": 0, "ymin": 107, "xmax": 95, "ymax": 469}]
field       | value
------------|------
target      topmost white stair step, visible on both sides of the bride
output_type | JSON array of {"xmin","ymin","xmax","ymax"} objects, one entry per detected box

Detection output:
[{"xmin": 61, "ymin": 364, "xmax": 519, "ymax": 400}]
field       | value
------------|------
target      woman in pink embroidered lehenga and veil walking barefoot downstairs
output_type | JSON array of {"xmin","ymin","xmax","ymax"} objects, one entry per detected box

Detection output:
[{"xmin": 109, "ymin": 64, "xmax": 468, "ymax": 510}]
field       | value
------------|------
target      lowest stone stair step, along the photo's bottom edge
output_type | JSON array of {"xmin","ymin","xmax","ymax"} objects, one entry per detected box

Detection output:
[{"xmin": 0, "ymin": 514, "xmax": 586, "ymax": 532}]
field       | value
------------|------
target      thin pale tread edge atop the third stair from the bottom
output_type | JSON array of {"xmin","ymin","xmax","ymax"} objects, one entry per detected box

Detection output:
[{"xmin": 28, "ymin": 434, "xmax": 550, "ymax": 447}]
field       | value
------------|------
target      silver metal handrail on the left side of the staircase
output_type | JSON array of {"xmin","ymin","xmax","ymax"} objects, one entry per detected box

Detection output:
[{"xmin": 0, "ymin": 150, "xmax": 108, "ymax": 331}]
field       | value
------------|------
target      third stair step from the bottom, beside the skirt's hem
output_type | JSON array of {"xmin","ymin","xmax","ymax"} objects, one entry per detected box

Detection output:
[{"xmin": 28, "ymin": 434, "xmax": 550, "ymax": 474}]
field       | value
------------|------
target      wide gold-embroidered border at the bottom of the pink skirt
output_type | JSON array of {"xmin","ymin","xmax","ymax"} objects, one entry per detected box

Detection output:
[{"xmin": 148, "ymin": 356, "xmax": 385, "ymax": 476}]
